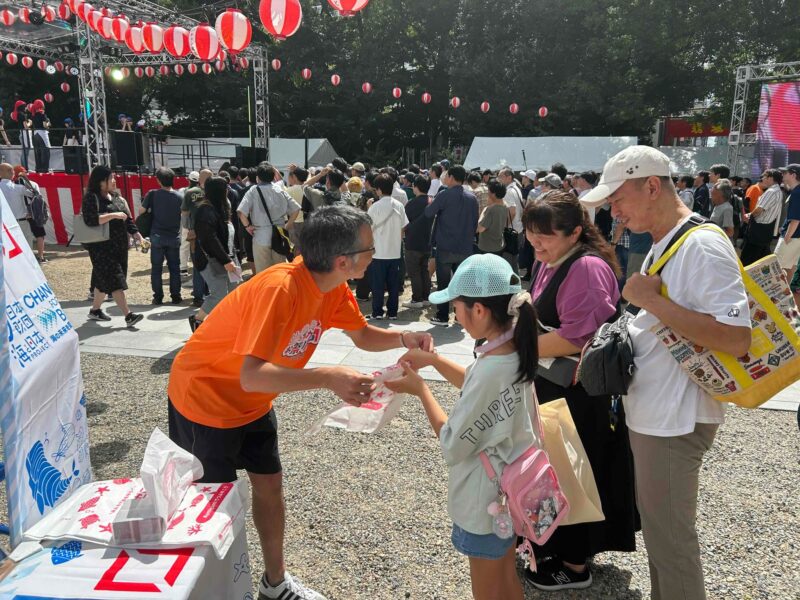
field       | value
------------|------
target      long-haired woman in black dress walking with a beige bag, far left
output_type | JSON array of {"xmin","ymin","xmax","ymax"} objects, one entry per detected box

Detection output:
[{"xmin": 81, "ymin": 165, "xmax": 144, "ymax": 327}]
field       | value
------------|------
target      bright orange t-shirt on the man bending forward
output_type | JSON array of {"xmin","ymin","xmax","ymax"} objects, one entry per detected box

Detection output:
[{"xmin": 168, "ymin": 258, "xmax": 367, "ymax": 429}]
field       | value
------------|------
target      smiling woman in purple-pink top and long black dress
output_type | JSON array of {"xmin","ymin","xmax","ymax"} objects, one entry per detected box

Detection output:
[{"xmin": 522, "ymin": 191, "xmax": 638, "ymax": 590}]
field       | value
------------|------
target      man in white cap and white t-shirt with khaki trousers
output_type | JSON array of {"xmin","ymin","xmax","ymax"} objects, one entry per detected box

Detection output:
[{"xmin": 580, "ymin": 146, "xmax": 751, "ymax": 600}]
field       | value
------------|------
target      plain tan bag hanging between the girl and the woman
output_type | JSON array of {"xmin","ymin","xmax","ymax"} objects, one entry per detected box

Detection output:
[{"xmin": 534, "ymin": 398, "xmax": 605, "ymax": 525}]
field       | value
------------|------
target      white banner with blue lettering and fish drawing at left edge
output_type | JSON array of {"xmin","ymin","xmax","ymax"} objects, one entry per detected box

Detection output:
[{"xmin": 0, "ymin": 192, "xmax": 92, "ymax": 547}]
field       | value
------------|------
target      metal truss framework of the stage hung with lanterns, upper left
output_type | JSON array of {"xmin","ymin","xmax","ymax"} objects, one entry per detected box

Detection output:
[{"xmin": 0, "ymin": 0, "xmax": 269, "ymax": 166}]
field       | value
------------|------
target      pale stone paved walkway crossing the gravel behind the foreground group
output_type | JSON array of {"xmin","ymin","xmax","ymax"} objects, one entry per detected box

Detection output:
[{"xmin": 62, "ymin": 302, "xmax": 800, "ymax": 411}]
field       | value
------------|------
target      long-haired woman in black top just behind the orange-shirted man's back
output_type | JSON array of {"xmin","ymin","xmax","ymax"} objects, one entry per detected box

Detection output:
[{"xmin": 189, "ymin": 177, "xmax": 241, "ymax": 331}]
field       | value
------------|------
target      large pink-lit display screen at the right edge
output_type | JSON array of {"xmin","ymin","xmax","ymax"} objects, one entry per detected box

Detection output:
[{"xmin": 752, "ymin": 81, "xmax": 800, "ymax": 180}]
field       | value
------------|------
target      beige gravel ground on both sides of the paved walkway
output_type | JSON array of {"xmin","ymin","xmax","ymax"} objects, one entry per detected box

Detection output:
[{"xmin": 0, "ymin": 245, "xmax": 800, "ymax": 600}]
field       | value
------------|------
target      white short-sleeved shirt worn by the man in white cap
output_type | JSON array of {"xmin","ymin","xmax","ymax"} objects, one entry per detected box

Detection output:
[{"xmin": 623, "ymin": 217, "xmax": 750, "ymax": 437}]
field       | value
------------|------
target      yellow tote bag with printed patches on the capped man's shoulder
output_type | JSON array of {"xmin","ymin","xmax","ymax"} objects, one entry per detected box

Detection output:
[{"xmin": 647, "ymin": 224, "xmax": 800, "ymax": 408}]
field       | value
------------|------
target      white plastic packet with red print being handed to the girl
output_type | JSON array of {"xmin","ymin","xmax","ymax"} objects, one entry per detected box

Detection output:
[{"xmin": 306, "ymin": 365, "xmax": 407, "ymax": 435}]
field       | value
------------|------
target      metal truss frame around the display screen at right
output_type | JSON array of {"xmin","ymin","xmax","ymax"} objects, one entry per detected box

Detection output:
[{"xmin": 728, "ymin": 62, "xmax": 800, "ymax": 168}]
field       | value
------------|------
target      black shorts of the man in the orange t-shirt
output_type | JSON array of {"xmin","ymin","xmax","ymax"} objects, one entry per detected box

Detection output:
[{"xmin": 167, "ymin": 398, "xmax": 281, "ymax": 483}]
